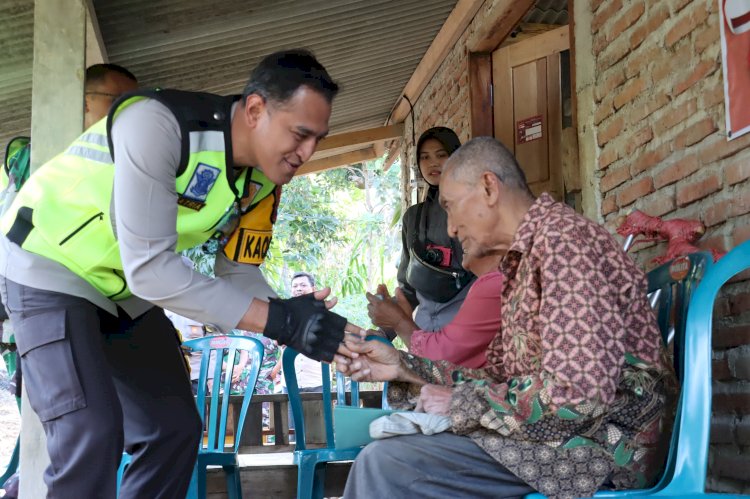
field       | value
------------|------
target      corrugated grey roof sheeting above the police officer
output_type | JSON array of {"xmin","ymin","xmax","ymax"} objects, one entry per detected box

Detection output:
[{"xmin": 0, "ymin": 0, "xmax": 456, "ymax": 152}]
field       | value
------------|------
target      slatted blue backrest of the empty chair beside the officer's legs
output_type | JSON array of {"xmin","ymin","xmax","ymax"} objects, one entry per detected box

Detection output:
[{"xmin": 184, "ymin": 336, "xmax": 263, "ymax": 453}]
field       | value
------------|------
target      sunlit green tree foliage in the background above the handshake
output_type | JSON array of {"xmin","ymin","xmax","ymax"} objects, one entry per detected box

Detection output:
[{"xmin": 262, "ymin": 159, "xmax": 401, "ymax": 327}]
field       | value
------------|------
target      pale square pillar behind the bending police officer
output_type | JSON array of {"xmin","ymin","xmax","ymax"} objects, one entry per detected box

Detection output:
[{"xmin": 20, "ymin": 0, "xmax": 86, "ymax": 499}]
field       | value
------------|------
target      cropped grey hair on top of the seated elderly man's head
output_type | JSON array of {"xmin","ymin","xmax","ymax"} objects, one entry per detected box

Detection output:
[{"xmin": 443, "ymin": 137, "xmax": 532, "ymax": 196}]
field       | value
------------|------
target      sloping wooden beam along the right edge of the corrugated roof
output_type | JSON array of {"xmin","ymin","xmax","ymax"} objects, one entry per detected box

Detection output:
[{"xmin": 386, "ymin": 0, "xmax": 484, "ymax": 124}]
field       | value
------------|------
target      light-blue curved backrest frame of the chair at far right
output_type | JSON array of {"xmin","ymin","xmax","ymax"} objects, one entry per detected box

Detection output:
[{"xmin": 662, "ymin": 241, "xmax": 750, "ymax": 495}]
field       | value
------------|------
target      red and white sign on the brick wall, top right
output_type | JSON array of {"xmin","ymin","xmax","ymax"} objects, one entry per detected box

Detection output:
[{"xmin": 717, "ymin": 0, "xmax": 750, "ymax": 140}]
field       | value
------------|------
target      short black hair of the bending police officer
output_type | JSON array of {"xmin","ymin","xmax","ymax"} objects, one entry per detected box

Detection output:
[{"xmin": 242, "ymin": 49, "xmax": 339, "ymax": 103}]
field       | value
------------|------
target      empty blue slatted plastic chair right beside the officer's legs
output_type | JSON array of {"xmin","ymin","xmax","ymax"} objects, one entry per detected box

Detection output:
[{"xmin": 117, "ymin": 335, "xmax": 263, "ymax": 499}]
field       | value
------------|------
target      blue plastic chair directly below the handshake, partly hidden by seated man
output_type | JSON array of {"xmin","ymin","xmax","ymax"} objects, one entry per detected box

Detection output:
[{"xmin": 282, "ymin": 347, "xmax": 362, "ymax": 498}]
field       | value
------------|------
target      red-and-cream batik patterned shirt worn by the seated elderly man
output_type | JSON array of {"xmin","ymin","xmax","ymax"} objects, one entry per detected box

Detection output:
[{"xmin": 389, "ymin": 194, "xmax": 677, "ymax": 498}]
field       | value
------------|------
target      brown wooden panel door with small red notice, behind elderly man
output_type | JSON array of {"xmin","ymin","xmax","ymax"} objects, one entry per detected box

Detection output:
[{"xmin": 492, "ymin": 26, "xmax": 570, "ymax": 201}]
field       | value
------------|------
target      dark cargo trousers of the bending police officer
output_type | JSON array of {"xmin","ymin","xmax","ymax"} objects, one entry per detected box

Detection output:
[{"xmin": 0, "ymin": 280, "xmax": 201, "ymax": 499}]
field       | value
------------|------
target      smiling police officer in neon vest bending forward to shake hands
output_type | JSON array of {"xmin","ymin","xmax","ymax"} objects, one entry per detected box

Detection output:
[{"xmin": 0, "ymin": 50, "xmax": 358, "ymax": 499}]
